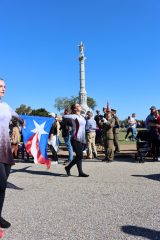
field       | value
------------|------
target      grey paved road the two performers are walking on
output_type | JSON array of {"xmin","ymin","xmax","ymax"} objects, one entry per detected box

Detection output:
[{"xmin": 3, "ymin": 152, "xmax": 160, "ymax": 240}]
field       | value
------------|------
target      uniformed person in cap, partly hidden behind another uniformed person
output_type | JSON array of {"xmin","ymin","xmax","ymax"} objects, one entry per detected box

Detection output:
[{"xmin": 111, "ymin": 108, "xmax": 120, "ymax": 153}]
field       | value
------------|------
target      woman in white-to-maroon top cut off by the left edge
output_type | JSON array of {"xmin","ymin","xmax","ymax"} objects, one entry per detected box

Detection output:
[{"xmin": 0, "ymin": 79, "xmax": 23, "ymax": 228}]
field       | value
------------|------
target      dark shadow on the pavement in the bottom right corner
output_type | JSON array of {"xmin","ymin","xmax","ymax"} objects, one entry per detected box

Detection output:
[{"xmin": 121, "ymin": 225, "xmax": 160, "ymax": 240}]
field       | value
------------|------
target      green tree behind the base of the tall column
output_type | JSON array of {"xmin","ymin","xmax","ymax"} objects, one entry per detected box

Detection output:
[{"xmin": 54, "ymin": 96, "xmax": 97, "ymax": 111}]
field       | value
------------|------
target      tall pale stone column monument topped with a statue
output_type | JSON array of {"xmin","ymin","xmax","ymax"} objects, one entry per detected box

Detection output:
[{"xmin": 79, "ymin": 42, "xmax": 90, "ymax": 113}]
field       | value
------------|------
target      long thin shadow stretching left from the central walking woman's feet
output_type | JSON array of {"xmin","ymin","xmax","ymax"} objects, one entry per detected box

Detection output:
[{"xmin": 11, "ymin": 166, "xmax": 67, "ymax": 177}]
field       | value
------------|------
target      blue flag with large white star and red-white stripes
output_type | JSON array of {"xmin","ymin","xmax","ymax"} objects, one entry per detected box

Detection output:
[{"xmin": 20, "ymin": 115, "xmax": 54, "ymax": 169}]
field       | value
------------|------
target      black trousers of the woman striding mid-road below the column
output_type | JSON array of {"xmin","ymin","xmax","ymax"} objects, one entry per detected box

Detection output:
[{"xmin": 67, "ymin": 140, "xmax": 84, "ymax": 174}]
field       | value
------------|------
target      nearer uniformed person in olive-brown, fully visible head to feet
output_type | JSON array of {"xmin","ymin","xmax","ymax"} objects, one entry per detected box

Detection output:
[{"xmin": 100, "ymin": 109, "xmax": 115, "ymax": 163}]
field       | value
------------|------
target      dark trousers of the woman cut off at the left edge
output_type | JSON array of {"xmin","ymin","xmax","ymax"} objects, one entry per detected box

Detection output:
[{"xmin": 0, "ymin": 163, "xmax": 11, "ymax": 216}]
